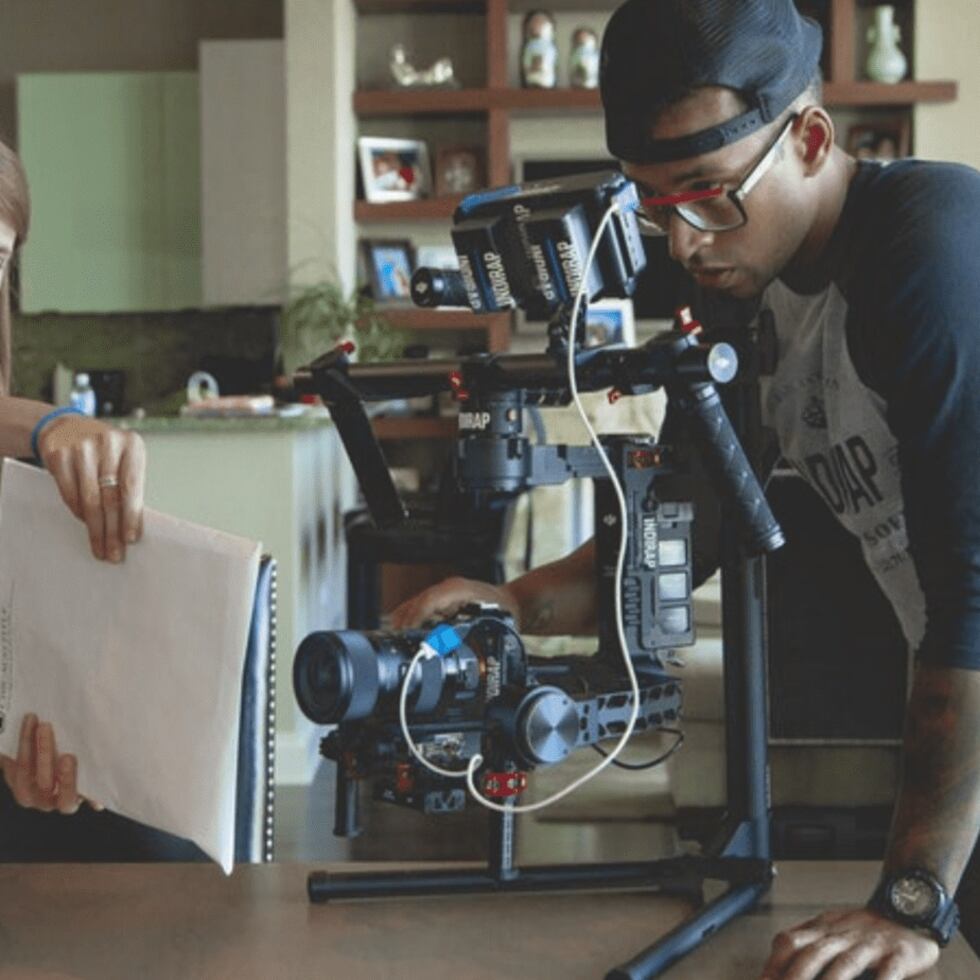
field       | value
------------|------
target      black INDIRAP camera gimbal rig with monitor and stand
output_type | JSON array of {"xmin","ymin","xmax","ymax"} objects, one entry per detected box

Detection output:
[{"xmin": 293, "ymin": 172, "xmax": 783, "ymax": 978}]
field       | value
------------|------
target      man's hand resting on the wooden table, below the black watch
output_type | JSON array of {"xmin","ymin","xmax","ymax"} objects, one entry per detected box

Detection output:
[{"xmin": 762, "ymin": 909, "xmax": 939, "ymax": 980}]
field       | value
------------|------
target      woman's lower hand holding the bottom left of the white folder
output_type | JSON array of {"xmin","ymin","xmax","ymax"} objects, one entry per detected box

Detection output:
[{"xmin": 0, "ymin": 715, "xmax": 102, "ymax": 814}]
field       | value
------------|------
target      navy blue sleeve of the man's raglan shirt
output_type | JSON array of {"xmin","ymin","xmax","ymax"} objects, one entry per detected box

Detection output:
[{"xmin": 847, "ymin": 161, "xmax": 980, "ymax": 669}]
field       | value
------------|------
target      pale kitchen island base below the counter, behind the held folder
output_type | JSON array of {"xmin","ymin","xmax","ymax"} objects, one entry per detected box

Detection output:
[{"xmin": 131, "ymin": 419, "xmax": 355, "ymax": 783}]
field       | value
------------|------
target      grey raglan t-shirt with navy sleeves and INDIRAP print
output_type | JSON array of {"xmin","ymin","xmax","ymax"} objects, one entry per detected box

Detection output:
[{"xmin": 762, "ymin": 160, "xmax": 980, "ymax": 669}]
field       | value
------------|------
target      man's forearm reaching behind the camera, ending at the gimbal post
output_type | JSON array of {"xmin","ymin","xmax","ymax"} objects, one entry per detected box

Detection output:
[{"xmin": 507, "ymin": 540, "xmax": 596, "ymax": 635}]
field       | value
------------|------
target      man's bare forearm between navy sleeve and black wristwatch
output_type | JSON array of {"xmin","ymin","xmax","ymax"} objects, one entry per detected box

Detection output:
[{"xmin": 885, "ymin": 667, "xmax": 980, "ymax": 893}]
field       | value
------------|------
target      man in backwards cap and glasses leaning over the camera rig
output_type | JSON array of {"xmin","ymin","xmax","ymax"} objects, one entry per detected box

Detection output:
[{"xmin": 392, "ymin": 0, "xmax": 980, "ymax": 980}]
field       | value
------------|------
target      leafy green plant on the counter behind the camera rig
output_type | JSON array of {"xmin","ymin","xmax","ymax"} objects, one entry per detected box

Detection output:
[{"xmin": 279, "ymin": 279, "xmax": 404, "ymax": 375}]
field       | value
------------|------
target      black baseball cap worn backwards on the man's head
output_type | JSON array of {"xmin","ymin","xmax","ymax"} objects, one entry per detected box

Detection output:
[{"xmin": 600, "ymin": 0, "xmax": 823, "ymax": 163}]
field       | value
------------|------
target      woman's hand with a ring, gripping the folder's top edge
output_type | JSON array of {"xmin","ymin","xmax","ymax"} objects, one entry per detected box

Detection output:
[{"xmin": 38, "ymin": 415, "xmax": 146, "ymax": 562}]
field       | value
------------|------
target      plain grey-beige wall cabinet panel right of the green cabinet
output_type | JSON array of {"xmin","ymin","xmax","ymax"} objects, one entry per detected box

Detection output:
[{"xmin": 200, "ymin": 40, "xmax": 287, "ymax": 306}]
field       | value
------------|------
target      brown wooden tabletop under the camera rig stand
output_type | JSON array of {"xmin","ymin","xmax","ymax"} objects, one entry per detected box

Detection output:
[{"xmin": 0, "ymin": 862, "xmax": 980, "ymax": 980}]
